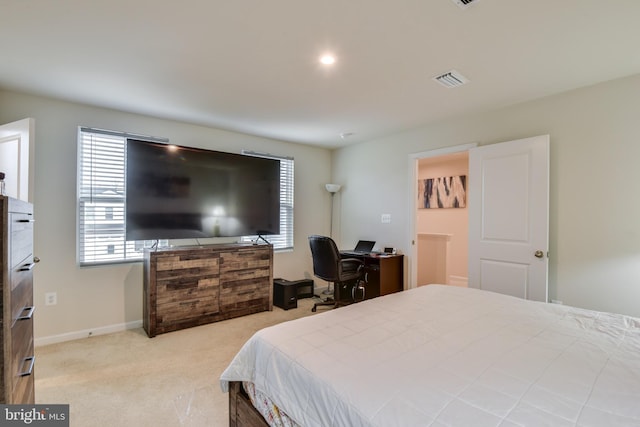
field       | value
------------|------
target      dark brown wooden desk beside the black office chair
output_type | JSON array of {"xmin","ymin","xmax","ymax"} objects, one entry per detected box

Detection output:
[{"xmin": 340, "ymin": 253, "xmax": 404, "ymax": 299}]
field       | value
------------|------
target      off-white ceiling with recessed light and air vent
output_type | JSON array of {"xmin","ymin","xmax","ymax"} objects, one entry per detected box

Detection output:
[{"xmin": 0, "ymin": 0, "xmax": 640, "ymax": 148}]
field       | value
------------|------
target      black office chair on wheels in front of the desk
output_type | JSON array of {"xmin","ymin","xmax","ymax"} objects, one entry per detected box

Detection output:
[{"xmin": 309, "ymin": 235, "xmax": 366, "ymax": 311}]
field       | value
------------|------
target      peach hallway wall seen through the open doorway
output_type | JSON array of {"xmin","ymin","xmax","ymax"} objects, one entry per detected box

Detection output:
[{"xmin": 416, "ymin": 151, "xmax": 469, "ymax": 284}]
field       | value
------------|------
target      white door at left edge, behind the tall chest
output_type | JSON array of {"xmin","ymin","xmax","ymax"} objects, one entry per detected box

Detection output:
[{"xmin": 0, "ymin": 119, "xmax": 35, "ymax": 201}]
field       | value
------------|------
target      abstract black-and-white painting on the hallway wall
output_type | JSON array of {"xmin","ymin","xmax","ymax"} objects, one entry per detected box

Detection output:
[{"xmin": 418, "ymin": 175, "xmax": 467, "ymax": 209}]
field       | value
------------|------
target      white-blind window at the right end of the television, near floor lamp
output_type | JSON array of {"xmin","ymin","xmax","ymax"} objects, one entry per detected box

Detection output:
[{"xmin": 242, "ymin": 151, "xmax": 294, "ymax": 250}]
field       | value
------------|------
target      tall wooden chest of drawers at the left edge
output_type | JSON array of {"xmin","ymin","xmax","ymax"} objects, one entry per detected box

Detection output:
[{"xmin": 0, "ymin": 196, "xmax": 35, "ymax": 404}]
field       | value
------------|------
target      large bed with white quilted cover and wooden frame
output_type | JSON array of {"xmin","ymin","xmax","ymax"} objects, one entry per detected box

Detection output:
[{"xmin": 220, "ymin": 285, "xmax": 640, "ymax": 427}]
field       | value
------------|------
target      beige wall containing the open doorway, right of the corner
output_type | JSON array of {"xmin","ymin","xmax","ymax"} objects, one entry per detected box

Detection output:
[{"xmin": 332, "ymin": 75, "xmax": 640, "ymax": 316}]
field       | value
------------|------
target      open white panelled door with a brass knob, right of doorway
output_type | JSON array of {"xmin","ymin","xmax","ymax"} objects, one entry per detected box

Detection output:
[{"xmin": 468, "ymin": 135, "xmax": 549, "ymax": 302}]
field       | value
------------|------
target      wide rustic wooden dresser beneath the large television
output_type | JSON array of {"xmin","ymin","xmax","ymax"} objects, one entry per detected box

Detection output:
[{"xmin": 143, "ymin": 244, "xmax": 273, "ymax": 337}]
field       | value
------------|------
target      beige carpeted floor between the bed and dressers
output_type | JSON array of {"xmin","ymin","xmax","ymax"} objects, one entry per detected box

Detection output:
[{"xmin": 35, "ymin": 299, "xmax": 325, "ymax": 427}]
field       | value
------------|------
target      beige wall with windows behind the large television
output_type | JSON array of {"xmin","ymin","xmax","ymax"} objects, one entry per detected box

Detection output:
[{"xmin": 0, "ymin": 91, "xmax": 331, "ymax": 343}]
